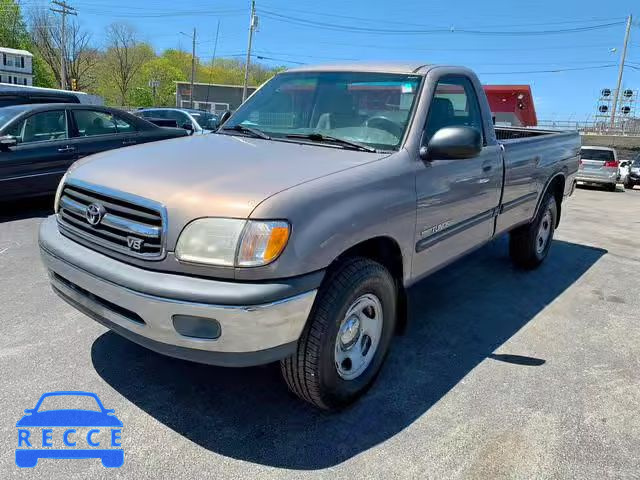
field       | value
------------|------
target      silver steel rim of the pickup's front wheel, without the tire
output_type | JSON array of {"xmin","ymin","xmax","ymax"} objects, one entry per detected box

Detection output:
[{"xmin": 334, "ymin": 293, "xmax": 383, "ymax": 380}]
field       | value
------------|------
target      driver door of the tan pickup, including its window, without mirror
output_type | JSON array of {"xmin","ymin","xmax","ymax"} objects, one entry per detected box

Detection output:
[{"xmin": 413, "ymin": 75, "xmax": 502, "ymax": 277}]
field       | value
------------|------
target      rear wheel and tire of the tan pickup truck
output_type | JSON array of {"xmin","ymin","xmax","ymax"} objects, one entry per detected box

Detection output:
[{"xmin": 509, "ymin": 192, "xmax": 558, "ymax": 270}]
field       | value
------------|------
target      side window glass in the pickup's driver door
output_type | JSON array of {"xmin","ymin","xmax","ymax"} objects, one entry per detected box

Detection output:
[{"xmin": 424, "ymin": 75, "xmax": 483, "ymax": 142}]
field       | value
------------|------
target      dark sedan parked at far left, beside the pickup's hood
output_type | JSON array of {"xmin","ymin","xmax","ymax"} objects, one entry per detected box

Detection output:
[{"xmin": 0, "ymin": 104, "xmax": 186, "ymax": 200}]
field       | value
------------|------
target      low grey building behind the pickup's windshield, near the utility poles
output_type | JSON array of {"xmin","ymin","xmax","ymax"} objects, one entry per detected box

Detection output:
[{"xmin": 176, "ymin": 82, "xmax": 256, "ymax": 113}]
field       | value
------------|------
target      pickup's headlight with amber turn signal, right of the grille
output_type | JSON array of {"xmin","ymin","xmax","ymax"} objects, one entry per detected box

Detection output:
[{"xmin": 176, "ymin": 218, "xmax": 290, "ymax": 267}]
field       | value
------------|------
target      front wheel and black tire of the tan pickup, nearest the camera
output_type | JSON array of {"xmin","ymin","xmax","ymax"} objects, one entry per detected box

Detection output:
[{"xmin": 280, "ymin": 257, "xmax": 397, "ymax": 410}]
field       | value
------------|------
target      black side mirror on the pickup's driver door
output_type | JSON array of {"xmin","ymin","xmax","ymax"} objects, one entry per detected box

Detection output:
[{"xmin": 420, "ymin": 126, "xmax": 482, "ymax": 160}]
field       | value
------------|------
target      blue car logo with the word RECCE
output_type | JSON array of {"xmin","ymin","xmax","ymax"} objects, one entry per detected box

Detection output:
[{"xmin": 16, "ymin": 391, "xmax": 124, "ymax": 468}]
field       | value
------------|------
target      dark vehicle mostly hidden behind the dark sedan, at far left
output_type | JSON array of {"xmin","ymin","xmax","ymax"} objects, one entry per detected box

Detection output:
[{"xmin": 0, "ymin": 84, "xmax": 104, "ymax": 107}]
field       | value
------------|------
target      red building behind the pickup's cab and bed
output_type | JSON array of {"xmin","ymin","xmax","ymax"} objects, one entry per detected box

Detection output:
[{"xmin": 483, "ymin": 85, "xmax": 538, "ymax": 127}]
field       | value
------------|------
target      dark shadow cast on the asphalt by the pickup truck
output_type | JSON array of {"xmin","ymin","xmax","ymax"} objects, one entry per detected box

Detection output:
[{"xmin": 91, "ymin": 238, "xmax": 606, "ymax": 470}]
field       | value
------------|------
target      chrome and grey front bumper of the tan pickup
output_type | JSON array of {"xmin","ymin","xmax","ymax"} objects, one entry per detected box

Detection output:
[{"xmin": 40, "ymin": 216, "xmax": 324, "ymax": 366}]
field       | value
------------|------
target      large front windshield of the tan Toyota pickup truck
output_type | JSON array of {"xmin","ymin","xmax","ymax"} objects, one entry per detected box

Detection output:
[{"xmin": 225, "ymin": 72, "xmax": 422, "ymax": 150}]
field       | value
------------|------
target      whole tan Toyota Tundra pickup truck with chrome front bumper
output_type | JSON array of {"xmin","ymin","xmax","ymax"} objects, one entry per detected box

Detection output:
[{"xmin": 40, "ymin": 64, "xmax": 580, "ymax": 409}]
